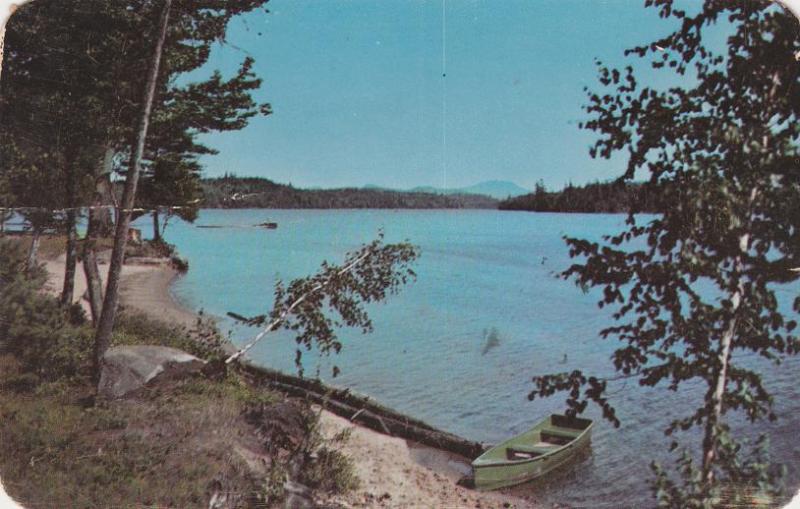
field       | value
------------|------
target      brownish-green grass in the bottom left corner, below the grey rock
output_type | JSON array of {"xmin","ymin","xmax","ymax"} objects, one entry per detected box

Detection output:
[{"xmin": 0, "ymin": 360, "xmax": 262, "ymax": 508}]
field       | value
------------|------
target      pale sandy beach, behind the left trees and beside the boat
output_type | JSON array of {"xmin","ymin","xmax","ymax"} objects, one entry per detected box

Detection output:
[{"xmin": 44, "ymin": 255, "xmax": 537, "ymax": 509}]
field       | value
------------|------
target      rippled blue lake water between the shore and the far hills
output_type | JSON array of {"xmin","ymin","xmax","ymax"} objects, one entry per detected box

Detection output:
[{"xmin": 139, "ymin": 210, "xmax": 800, "ymax": 508}]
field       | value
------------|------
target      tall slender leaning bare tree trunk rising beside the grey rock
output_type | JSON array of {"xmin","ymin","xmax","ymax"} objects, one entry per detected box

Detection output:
[{"xmin": 93, "ymin": 0, "xmax": 172, "ymax": 382}]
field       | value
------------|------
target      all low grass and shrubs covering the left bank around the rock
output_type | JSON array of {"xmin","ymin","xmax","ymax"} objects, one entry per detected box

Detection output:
[{"xmin": 0, "ymin": 240, "xmax": 357, "ymax": 508}]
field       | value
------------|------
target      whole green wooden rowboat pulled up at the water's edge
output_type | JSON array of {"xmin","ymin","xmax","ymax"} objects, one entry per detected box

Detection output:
[{"xmin": 472, "ymin": 414, "xmax": 593, "ymax": 490}]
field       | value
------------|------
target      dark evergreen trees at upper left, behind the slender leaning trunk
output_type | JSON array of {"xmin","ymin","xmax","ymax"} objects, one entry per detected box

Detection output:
[{"xmin": 0, "ymin": 0, "xmax": 269, "ymax": 318}]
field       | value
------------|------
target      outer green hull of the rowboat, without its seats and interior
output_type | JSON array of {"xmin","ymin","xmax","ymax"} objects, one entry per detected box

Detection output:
[{"xmin": 472, "ymin": 416, "xmax": 592, "ymax": 490}]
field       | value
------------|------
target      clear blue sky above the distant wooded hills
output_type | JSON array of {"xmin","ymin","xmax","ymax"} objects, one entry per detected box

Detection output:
[{"xmin": 194, "ymin": 0, "xmax": 720, "ymax": 189}]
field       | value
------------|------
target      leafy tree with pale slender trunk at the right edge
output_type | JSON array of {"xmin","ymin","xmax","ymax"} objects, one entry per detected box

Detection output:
[{"xmin": 529, "ymin": 0, "xmax": 800, "ymax": 506}]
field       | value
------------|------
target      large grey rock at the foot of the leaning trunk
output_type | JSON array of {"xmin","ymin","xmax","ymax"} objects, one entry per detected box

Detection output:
[{"xmin": 98, "ymin": 345, "xmax": 205, "ymax": 399}]
